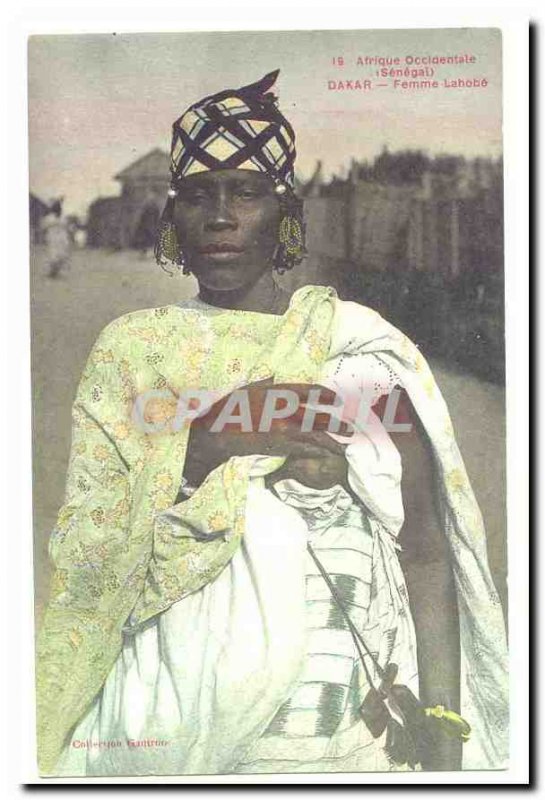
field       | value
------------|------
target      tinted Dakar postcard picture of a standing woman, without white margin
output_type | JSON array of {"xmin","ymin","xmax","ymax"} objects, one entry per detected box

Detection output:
[{"xmin": 28, "ymin": 28, "xmax": 510, "ymax": 782}]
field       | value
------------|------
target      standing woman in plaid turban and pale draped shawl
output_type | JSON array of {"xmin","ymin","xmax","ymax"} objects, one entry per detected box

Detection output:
[{"xmin": 38, "ymin": 73, "xmax": 507, "ymax": 775}]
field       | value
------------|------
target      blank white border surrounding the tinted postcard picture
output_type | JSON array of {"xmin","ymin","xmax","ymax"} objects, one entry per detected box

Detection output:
[{"xmin": 0, "ymin": 0, "xmax": 537, "ymax": 794}]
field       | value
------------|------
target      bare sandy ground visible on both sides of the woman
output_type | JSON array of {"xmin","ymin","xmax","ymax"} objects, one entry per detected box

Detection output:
[{"xmin": 31, "ymin": 247, "xmax": 506, "ymax": 613}]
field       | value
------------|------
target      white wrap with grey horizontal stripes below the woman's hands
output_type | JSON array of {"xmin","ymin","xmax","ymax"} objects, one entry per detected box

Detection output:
[{"xmin": 235, "ymin": 481, "xmax": 418, "ymax": 773}]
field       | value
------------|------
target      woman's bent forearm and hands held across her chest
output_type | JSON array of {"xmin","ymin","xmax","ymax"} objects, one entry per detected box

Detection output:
[{"xmin": 184, "ymin": 380, "xmax": 347, "ymax": 488}]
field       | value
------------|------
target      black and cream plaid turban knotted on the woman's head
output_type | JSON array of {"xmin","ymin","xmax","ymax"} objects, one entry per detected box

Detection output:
[{"xmin": 170, "ymin": 70, "xmax": 295, "ymax": 187}]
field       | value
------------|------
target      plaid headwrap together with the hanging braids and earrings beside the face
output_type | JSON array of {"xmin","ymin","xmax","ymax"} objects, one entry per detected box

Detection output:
[{"xmin": 155, "ymin": 70, "xmax": 307, "ymax": 274}]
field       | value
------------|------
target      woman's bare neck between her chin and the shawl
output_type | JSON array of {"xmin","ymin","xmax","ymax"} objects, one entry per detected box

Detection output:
[{"xmin": 199, "ymin": 272, "xmax": 290, "ymax": 314}]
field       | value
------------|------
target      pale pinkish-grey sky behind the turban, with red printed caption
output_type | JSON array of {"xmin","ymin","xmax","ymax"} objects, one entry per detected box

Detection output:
[{"xmin": 29, "ymin": 28, "xmax": 502, "ymax": 214}]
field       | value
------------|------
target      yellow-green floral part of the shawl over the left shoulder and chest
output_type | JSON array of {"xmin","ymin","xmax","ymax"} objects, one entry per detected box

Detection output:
[{"xmin": 37, "ymin": 286, "xmax": 335, "ymax": 774}]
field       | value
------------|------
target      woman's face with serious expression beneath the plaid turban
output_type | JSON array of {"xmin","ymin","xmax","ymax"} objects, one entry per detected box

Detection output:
[{"xmin": 174, "ymin": 169, "xmax": 280, "ymax": 291}]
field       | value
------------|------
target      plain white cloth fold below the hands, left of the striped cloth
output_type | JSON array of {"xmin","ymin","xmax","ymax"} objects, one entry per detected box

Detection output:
[{"xmin": 57, "ymin": 483, "xmax": 306, "ymax": 775}]
